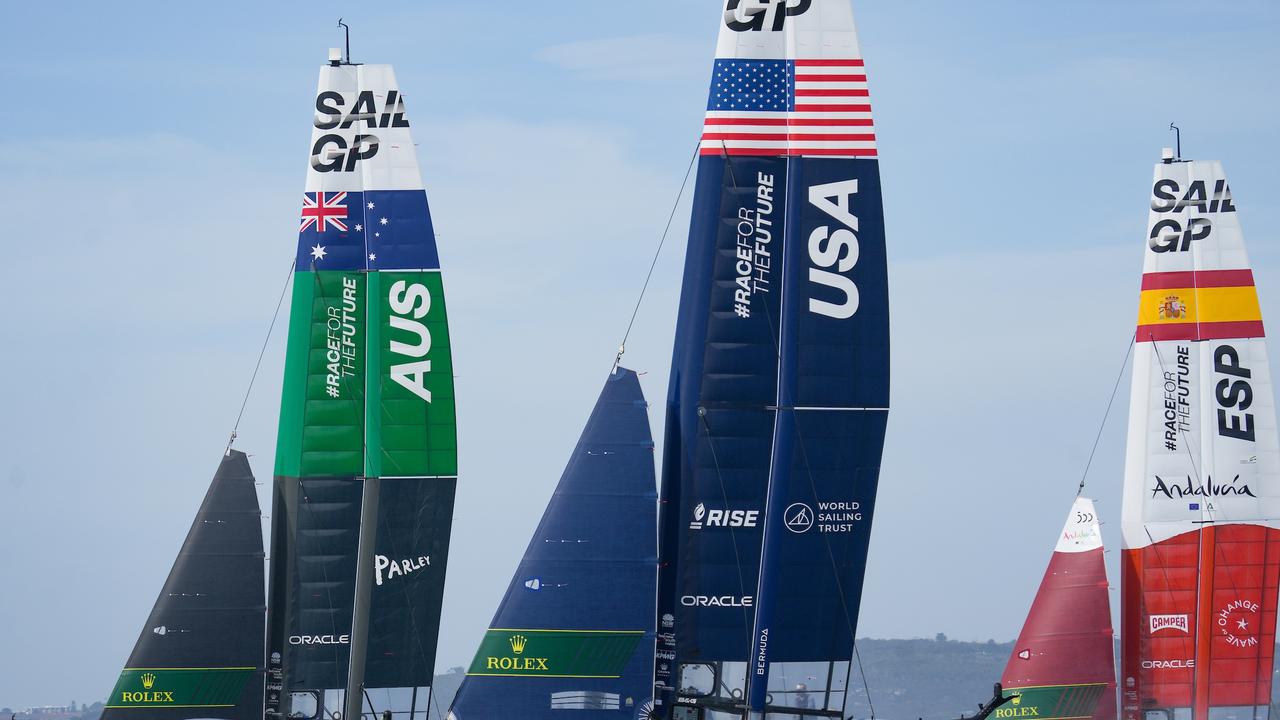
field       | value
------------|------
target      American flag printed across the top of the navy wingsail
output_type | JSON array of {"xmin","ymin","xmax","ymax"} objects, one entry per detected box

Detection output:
[{"xmin": 701, "ymin": 59, "xmax": 876, "ymax": 158}]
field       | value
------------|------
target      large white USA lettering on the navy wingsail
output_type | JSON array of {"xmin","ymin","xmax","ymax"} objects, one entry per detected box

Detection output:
[{"xmin": 809, "ymin": 179, "xmax": 859, "ymax": 320}]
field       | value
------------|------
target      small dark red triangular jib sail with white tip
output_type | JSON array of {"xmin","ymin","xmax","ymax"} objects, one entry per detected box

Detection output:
[{"xmin": 995, "ymin": 497, "xmax": 1116, "ymax": 720}]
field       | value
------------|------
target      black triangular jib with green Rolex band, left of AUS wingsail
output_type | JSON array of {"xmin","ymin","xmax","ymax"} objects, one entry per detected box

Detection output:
[{"xmin": 102, "ymin": 450, "xmax": 265, "ymax": 720}]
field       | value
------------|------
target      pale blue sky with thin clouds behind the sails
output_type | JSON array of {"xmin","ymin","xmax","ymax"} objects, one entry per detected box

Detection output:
[{"xmin": 0, "ymin": 0, "xmax": 1280, "ymax": 708}]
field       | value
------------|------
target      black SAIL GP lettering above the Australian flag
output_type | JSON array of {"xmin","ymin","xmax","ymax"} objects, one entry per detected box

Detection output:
[{"xmin": 311, "ymin": 90, "xmax": 408, "ymax": 173}]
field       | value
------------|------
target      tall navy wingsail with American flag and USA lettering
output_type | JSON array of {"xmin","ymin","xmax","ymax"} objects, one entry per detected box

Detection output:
[{"xmin": 654, "ymin": 0, "xmax": 888, "ymax": 717}]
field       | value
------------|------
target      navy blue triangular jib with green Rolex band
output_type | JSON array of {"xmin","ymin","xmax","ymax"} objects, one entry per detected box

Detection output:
[{"xmin": 451, "ymin": 368, "xmax": 657, "ymax": 720}]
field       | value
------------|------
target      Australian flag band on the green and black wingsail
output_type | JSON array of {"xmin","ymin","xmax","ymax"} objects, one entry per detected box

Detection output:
[{"xmin": 297, "ymin": 190, "xmax": 440, "ymax": 272}]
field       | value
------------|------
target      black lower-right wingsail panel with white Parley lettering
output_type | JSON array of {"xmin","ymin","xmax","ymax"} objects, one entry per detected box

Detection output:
[{"xmin": 365, "ymin": 478, "xmax": 457, "ymax": 688}]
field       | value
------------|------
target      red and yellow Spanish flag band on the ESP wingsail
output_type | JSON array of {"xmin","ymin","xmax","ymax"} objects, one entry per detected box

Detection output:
[{"xmin": 1137, "ymin": 270, "xmax": 1265, "ymax": 342}]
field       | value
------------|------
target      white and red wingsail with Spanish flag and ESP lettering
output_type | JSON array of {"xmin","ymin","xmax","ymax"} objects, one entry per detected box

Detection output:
[{"xmin": 1120, "ymin": 150, "xmax": 1280, "ymax": 720}]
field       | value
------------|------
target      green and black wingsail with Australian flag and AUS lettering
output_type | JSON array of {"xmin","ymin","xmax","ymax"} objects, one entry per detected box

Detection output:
[{"xmin": 266, "ymin": 54, "xmax": 457, "ymax": 717}]
